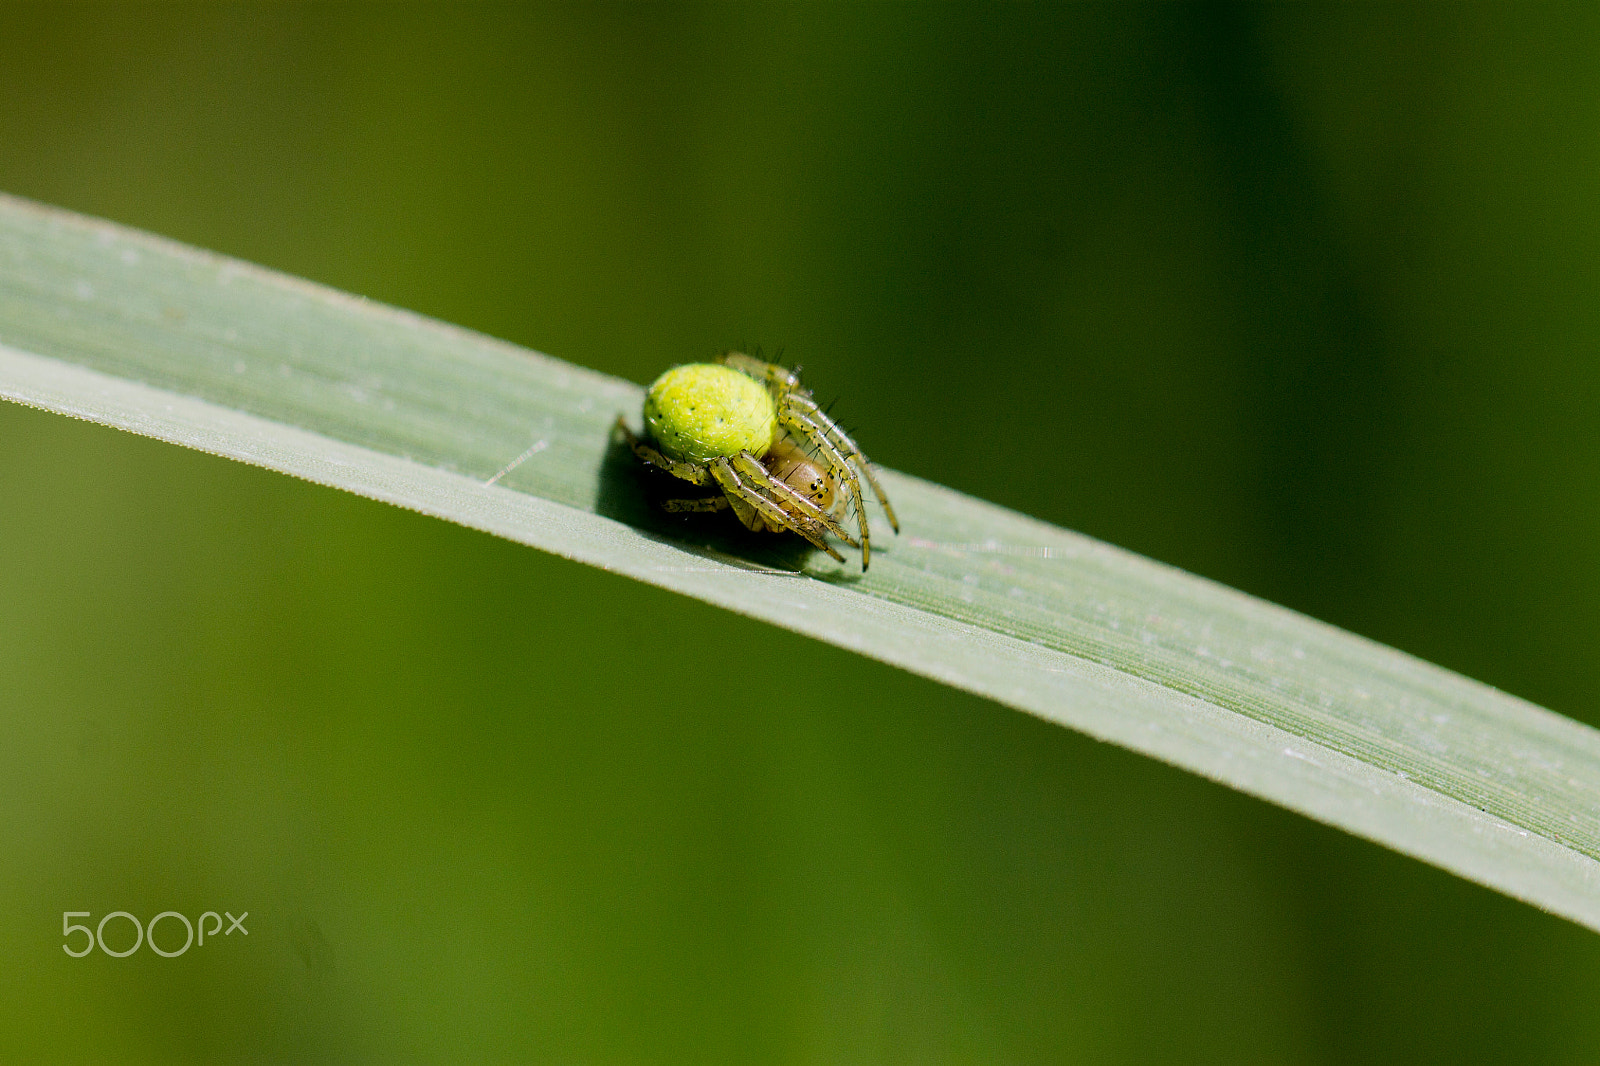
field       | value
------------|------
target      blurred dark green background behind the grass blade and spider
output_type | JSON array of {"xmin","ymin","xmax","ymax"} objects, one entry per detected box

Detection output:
[{"xmin": 0, "ymin": 3, "xmax": 1600, "ymax": 1063}]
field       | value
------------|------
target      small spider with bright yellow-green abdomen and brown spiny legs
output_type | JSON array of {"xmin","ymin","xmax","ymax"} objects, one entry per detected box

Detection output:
[{"xmin": 616, "ymin": 352, "xmax": 899, "ymax": 571}]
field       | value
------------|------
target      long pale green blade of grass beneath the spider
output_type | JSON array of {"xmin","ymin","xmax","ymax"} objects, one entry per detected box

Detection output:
[{"xmin": 9, "ymin": 197, "xmax": 1600, "ymax": 928}]
